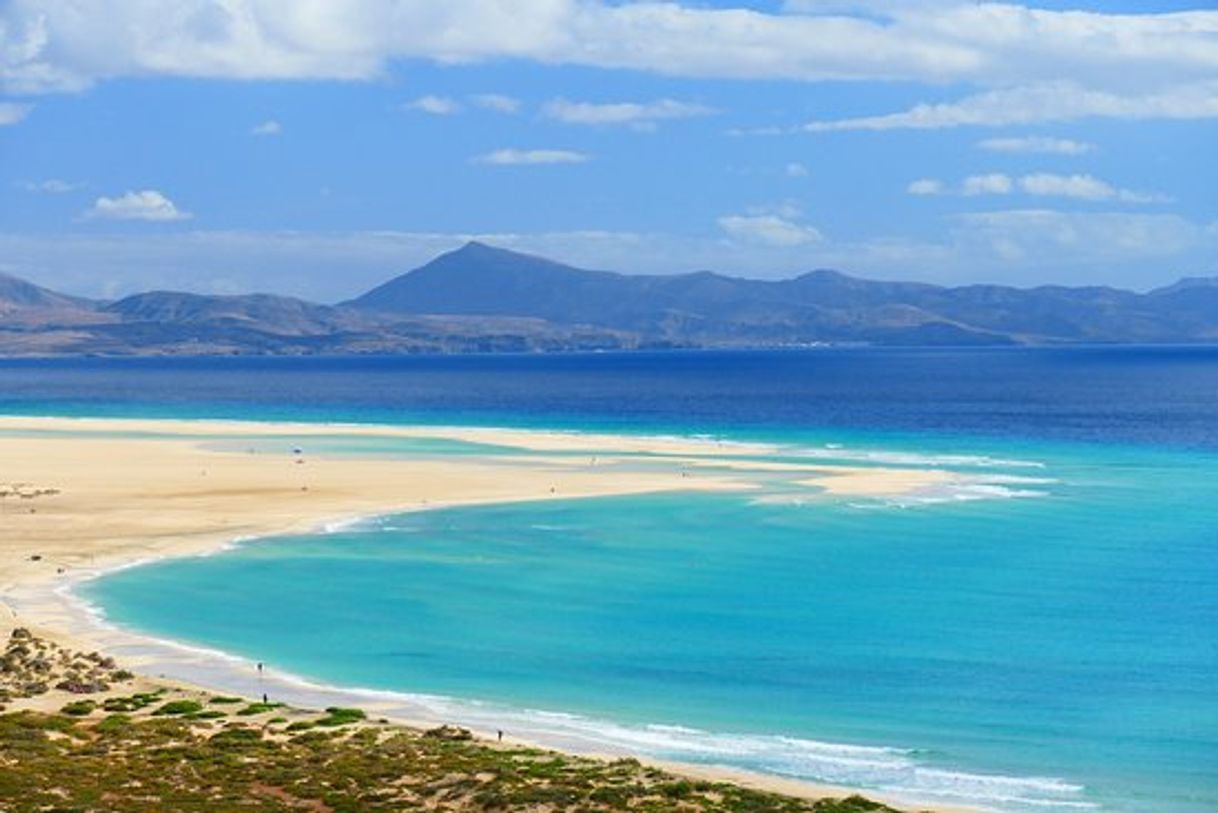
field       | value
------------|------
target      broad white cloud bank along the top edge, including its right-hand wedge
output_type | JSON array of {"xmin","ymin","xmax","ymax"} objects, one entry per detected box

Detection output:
[{"xmin": 0, "ymin": 0, "xmax": 1218, "ymax": 130}]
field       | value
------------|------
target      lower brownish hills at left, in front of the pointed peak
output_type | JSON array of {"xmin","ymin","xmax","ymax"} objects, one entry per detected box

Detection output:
[{"xmin": 0, "ymin": 266, "xmax": 637, "ymax": 356}]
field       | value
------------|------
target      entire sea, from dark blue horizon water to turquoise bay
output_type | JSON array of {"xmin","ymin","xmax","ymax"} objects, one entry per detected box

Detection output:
[{"xmin": 0, "ymin": 347, "xmax": 1218, "ymax": 813}]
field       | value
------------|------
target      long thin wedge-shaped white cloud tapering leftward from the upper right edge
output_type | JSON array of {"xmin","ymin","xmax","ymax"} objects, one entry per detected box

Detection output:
[{"xmin": 803, "ymin": 81, "xmax": 1218, "ymax": 133}]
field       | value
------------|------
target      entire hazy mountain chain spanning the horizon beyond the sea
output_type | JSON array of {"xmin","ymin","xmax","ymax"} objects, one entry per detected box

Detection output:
[{"xmin": 0, "ymin": 243, "xmax": 1218, "ymax": 356}]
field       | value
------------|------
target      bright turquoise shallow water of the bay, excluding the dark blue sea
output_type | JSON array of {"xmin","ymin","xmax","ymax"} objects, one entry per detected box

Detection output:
[{"xmin": 78, "ymin": 429, "xmax": 1218, "ymax": 813}]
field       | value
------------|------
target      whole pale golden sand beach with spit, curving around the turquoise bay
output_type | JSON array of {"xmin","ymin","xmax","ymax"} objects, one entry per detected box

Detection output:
[{"xmin": 0, "ymin": 417, "xmax": 969, "ymax": 811}]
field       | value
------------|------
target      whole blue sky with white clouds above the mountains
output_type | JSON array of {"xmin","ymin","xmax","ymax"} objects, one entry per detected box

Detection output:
[{"xmin": 0, "ymin": 0, "xmax": 1218, "ymax": 302}]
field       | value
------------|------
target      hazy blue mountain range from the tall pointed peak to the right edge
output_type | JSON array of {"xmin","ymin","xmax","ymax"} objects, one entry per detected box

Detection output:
[{"xmin": 347, "ymin": 243, "xmax": 1218, "ymax": 345}]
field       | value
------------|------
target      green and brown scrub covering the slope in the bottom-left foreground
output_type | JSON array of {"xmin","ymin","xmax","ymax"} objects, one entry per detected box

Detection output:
[{"xmin": 0, "ymin": 630, "xmax": 915, "ymax": 813}]
